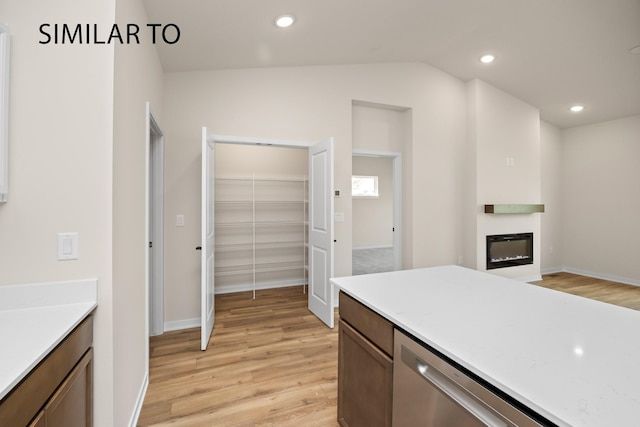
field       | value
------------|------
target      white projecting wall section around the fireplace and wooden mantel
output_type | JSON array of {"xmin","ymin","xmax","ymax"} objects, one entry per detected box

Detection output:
[{"xmin": 467, "ymin": 80, "xmax": 541, "ymax": 280}]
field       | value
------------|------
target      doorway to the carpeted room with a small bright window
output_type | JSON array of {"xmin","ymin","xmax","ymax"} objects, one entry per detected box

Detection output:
[{"xmin": 351, "ymin": 150, "xmax": 402, "ymax": 276}]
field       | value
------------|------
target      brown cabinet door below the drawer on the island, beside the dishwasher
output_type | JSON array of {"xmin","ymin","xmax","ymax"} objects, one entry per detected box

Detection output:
[{"xmin": 338, "ymin": 320, "xmax": 393, "ymax": 427}]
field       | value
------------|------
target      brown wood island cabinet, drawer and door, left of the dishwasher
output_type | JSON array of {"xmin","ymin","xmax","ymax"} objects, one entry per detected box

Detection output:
[{"xmin": 338, "ymin": 292, "xmax": 393, "ymax": 427}]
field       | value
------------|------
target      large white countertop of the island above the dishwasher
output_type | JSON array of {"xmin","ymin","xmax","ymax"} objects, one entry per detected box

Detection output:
[{"xmin": 331, "ymin": 266, "xmax": 640, "ymax": 427}]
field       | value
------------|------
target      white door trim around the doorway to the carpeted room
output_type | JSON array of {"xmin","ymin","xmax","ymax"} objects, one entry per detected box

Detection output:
[{"xmin": 351, "ymin": 148, "xmax": 403, "ymax": 270}]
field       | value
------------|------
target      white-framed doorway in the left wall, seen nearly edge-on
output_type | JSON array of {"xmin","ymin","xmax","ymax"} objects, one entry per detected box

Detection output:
[{"xmin": 145, "ymin": 102, "xmax": 164, "ymax": 340}]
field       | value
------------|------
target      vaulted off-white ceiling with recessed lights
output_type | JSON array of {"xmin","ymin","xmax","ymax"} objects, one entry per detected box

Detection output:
[{"xmin": 145, "ymin": 0, "xmax": 640, "ymax": 128}]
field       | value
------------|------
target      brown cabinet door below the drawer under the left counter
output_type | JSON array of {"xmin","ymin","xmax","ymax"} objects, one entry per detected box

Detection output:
[{"xmin": 44, "ymin": 349, "xmax": 93, "ymax": 427}]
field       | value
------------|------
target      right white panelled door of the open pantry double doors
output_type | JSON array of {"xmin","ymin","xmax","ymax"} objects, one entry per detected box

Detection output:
[{"xmin": 309, "ymin": 138, "xmax": 333, "ymax": 328}]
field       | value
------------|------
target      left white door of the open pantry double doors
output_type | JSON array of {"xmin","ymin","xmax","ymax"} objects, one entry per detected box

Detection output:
[{"xmin": 200, "ymin": 127, "xmax": 215, "ymax": 350}]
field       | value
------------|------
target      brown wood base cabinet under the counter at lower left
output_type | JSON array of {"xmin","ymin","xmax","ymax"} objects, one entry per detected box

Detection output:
[{"xmin": 0, "ymin": 316, "xmax": 93, "ymax": 427}]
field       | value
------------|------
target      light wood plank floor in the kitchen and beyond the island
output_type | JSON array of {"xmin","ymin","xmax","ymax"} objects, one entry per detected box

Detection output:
[{"xmin": 138, "ymin": 273, "xmax": 640, "ymax": 427}]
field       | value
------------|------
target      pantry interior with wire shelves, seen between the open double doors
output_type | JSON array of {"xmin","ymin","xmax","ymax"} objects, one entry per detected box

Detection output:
[{"xmin": 215, "ymin": 143, "xmax": 308, "ymax": 299}]
